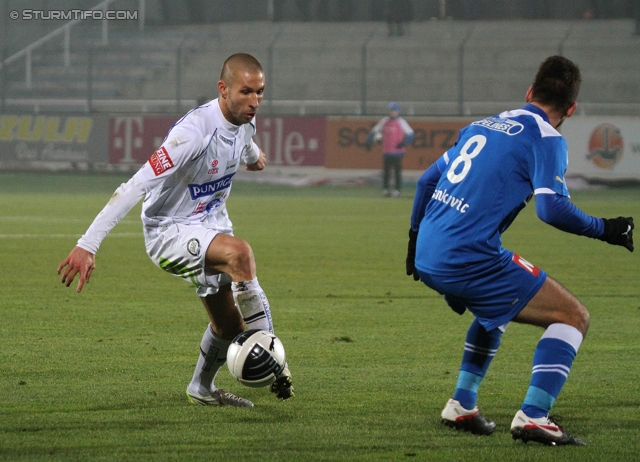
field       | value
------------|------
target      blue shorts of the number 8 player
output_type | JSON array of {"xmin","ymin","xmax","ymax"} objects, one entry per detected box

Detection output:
[{"xmin": 418, "ymin": 251, "xmax": 547, "ymax": 330}]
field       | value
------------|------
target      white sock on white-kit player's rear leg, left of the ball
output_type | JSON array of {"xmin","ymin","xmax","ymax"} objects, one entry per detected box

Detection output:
[{"xmin": 189, "ymin": 325, "xmax": 231, "ymax": 395}]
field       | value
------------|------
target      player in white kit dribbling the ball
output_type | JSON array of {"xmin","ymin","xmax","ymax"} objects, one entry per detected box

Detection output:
[{"xmin": 58, "ymin": 53, "xmax": 293, "ymax": 407}]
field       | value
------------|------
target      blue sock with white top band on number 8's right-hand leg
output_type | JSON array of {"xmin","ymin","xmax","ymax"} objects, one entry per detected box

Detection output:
[{"xmin": 522, "ymin": 324, "xmax": 582, "ymax": 419}]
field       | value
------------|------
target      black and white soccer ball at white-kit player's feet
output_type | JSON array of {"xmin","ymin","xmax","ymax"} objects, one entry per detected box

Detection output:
[{"xmin": 227, "ymin": 329, "xmax": 286, "ymax": 388}]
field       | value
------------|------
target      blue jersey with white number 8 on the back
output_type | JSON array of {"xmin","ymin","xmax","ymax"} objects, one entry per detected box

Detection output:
[{"xmin": 415, "ymin": 104, "xmax": 569, "ymax": 276}]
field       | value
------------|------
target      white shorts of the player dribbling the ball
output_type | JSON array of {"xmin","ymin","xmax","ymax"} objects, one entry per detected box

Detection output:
[{"xmin": 144, "ymin": 223, "xmax": 233, "ymax": 297}]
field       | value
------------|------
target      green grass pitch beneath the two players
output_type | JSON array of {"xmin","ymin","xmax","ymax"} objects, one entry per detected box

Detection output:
[{"xmin": 0, "ymin": 173, "xmax": 640, "ymax": 462}]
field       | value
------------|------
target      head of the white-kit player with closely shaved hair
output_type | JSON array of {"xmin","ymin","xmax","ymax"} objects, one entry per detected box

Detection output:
[{"xmin": 218, "ymin": 53, "xmax": 264, "ymax": 125}]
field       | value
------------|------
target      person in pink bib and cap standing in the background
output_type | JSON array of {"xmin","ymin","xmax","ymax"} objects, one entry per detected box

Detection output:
[{"xmin": 366, "ymin": 103, "xmax": 414, "ymax": 197}]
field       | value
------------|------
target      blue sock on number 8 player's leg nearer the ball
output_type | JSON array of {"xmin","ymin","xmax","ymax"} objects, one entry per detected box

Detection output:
[{"xmin": 453, "ymin": 319, "xmax": 506, "ymax": 409}]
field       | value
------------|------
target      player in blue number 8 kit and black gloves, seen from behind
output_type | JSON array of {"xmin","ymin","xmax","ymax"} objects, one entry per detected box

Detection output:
[{"xmin": 406, "ymin": 56, "xmax": 633, "ymax": 446}]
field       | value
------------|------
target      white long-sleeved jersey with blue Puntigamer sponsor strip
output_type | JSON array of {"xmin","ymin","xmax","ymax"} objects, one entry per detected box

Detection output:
[{"xmin": 78, "ymin": 99, "xmax": 260, "ymax": 254}]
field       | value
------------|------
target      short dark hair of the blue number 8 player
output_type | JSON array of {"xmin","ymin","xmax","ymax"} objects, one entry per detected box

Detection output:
[{"xmin": 531, "ymin": 56, "xmax": 582, "ymax": 112}]
